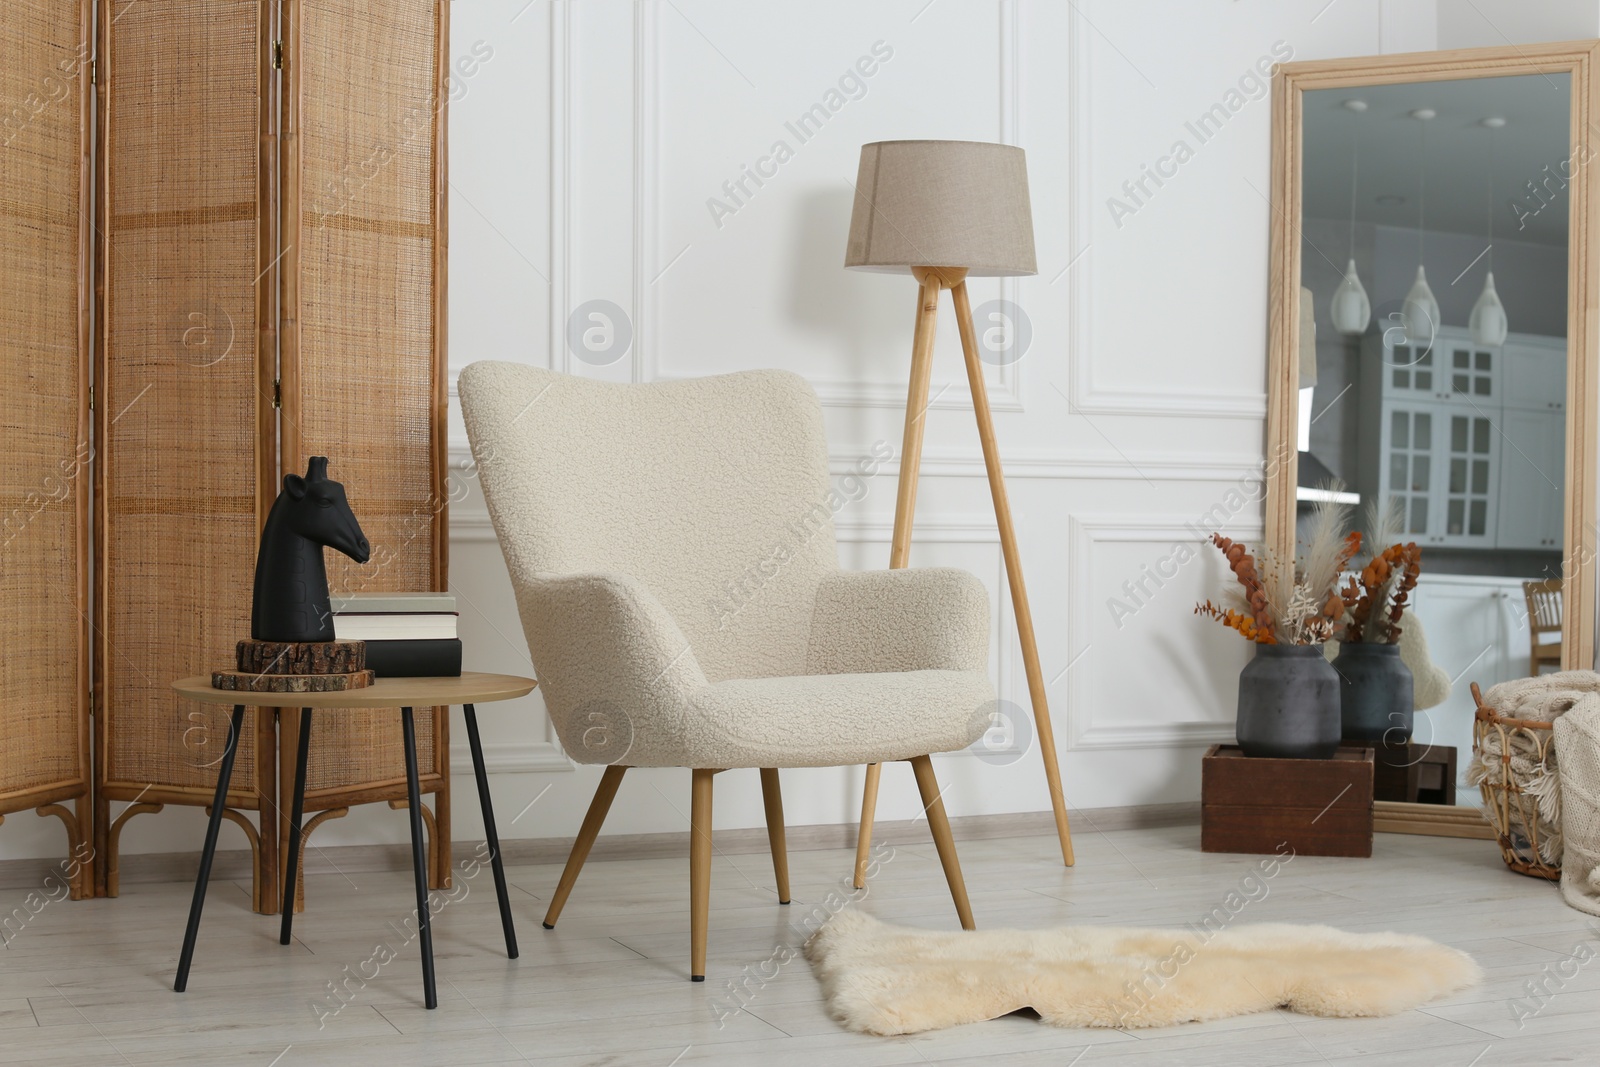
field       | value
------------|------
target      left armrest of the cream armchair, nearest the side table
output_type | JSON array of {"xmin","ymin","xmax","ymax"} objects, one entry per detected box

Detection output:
[{"xmin": 517, "ymin": 573, "xmax": 707, "ymax": 763}]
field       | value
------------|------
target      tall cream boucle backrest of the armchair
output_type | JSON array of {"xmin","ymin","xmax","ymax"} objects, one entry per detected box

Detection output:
[{"xmin": 459, "ymin": 362, "xmax": 838, "ymax": 681}]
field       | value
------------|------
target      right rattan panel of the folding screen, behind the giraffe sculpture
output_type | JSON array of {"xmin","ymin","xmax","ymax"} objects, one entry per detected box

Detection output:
[{"xmin": 282, "ymin": 0, "xmax": 448, "ymax": 803}]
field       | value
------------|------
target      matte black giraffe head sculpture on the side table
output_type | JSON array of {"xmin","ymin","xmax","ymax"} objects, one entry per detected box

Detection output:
[{"xmin": 250, "ymin": 456, "xmax": 371, "ymax": 641}]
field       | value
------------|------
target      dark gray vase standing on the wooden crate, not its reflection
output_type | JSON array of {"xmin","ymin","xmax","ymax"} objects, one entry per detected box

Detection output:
[{"xmin": 1237, "ymin": 645, "xmax": 1339, "ymax": 760}]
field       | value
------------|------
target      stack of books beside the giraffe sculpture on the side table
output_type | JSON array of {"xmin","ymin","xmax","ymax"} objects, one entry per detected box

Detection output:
[{"xmin": 333, "ymin": 593, "xmax": 461, "ymax": 678}]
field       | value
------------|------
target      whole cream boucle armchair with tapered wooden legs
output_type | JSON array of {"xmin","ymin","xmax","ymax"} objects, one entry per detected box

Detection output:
[{"xmin": 459, "ymin": 362, "xmax": 995, "ymax": 981}]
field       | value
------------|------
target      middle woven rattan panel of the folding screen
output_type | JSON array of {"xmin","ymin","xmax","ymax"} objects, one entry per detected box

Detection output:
[{"xmin": 98, "ymin": 0, "xmax": 274, "ymax": 806}]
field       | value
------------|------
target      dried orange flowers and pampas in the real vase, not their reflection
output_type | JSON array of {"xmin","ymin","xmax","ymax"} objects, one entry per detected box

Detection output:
[{"xmin": 1195, "ymin": 493, "xmax": 1362, "ymax": 645}]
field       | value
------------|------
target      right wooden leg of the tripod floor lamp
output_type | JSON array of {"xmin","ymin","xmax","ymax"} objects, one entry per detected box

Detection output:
[{"xmin": 950, "ymin": 280, "xmax": 1072, "ymax": 867}]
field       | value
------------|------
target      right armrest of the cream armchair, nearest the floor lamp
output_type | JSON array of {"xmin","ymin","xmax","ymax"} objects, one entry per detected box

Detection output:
[{"xmin": 806, "ymin": 566, "xmax": 989, "ymax": 673}]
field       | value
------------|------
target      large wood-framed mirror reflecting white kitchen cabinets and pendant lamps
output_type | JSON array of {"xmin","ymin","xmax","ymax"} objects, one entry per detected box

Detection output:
[{"xmin": 1267, "ymin": 42, "xmax": 1600, "ymax": 835}]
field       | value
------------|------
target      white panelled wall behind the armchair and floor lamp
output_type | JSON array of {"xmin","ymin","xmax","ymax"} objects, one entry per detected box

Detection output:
[{"xmin": 12, "ymin": 0, "xmax": 1595, "ymax": 856}]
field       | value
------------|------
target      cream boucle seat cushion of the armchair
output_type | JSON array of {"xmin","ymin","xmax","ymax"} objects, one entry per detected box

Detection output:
[{"xmin": 622, "ymin": 670, "xmax": 995, "ymax": 769}]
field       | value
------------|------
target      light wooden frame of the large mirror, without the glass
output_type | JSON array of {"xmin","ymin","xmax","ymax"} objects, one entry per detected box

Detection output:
[{"xmin": 1266, "ymin": 40, "xmax": 1600, "ymax": 838}]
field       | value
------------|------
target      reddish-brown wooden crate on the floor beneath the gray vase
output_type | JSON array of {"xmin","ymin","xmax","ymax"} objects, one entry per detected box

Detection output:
[{"xmin": 1200, "ymin": 745, "xmax": 1373, "ymax": 856}]
